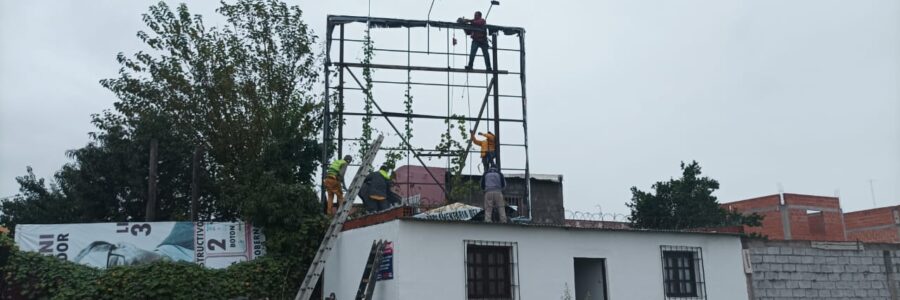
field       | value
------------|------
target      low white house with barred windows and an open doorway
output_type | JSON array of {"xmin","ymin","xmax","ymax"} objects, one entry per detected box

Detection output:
[{"xmin": 324, "ymin": 212, "xmax": 747, "ymax": 300}]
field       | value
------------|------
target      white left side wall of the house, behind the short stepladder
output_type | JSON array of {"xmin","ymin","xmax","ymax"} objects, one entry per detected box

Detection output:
[{"xmin": 323, "ymin": 221, "xmax": 403, "ymax": 299}]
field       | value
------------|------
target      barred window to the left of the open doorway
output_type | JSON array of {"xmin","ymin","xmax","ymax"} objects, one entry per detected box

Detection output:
[{"xmin": 466, "ymin": 241, "xmax": 518, "ymax": 300}]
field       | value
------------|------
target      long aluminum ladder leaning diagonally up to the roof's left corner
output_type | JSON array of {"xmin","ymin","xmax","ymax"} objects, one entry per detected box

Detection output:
[{"xmin": 294, "ymin": 135, "xmax": 384, "ymax": 300}]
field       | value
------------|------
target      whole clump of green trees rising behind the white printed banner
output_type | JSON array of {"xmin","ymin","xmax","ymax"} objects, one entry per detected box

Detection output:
[{"xmin": 2, "ymin": 0, "xmax": 324, "ymax": 258}]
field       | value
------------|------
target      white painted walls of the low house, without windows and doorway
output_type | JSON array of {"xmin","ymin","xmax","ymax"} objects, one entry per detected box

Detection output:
[{"xmin": 326, "ymin": 220, "xmax": 747, "ymax": 300}]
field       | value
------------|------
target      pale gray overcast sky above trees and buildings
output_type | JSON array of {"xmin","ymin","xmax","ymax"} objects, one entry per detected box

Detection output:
[{"xmin": 0, "ymin": 0, "xmax": 900, "ymax": 213}]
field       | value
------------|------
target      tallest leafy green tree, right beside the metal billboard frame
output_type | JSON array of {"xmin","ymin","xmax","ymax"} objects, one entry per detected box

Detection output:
[{"xmin": 101, "ymin": 0, "xmax": 330, "ymax": 253}]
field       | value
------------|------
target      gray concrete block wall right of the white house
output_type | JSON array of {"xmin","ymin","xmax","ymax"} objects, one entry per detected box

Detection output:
[{"xmin": 744, "ymin": 240, "xmax": 900, "ymax": 300}]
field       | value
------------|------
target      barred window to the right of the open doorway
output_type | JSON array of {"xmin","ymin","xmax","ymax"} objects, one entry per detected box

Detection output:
[{"xmin": 660, "ymin": 246, "xmax": 706, "ymax": 299}]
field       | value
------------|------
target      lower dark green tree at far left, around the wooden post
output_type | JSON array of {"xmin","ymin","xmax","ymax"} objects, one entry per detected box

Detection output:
[{"xmin": 0, "ymin": 112, "xmax": 212, "ymax": 232}]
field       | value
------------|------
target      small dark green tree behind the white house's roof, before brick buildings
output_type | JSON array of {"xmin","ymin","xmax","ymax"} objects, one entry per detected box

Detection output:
[{"xmin": 626, "ymin": 161, "xmax": 762, "ymax": 229}]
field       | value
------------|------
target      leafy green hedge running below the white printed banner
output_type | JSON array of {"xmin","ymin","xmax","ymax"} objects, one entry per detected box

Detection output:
[{"xmin": 0, "ymin": 235, "xmax": 320, "ymax": 299}]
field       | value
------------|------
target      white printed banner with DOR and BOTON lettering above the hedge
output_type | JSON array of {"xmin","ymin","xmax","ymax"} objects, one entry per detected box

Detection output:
[{"xmin": 15, "ymin": 222, "xmax": 265, "ymax": 268}]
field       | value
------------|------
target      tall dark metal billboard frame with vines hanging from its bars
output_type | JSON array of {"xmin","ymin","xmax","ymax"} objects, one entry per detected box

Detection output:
[{"xmin": 321, "ymin": 15, "xmax": 531, "ymax": 221}]
